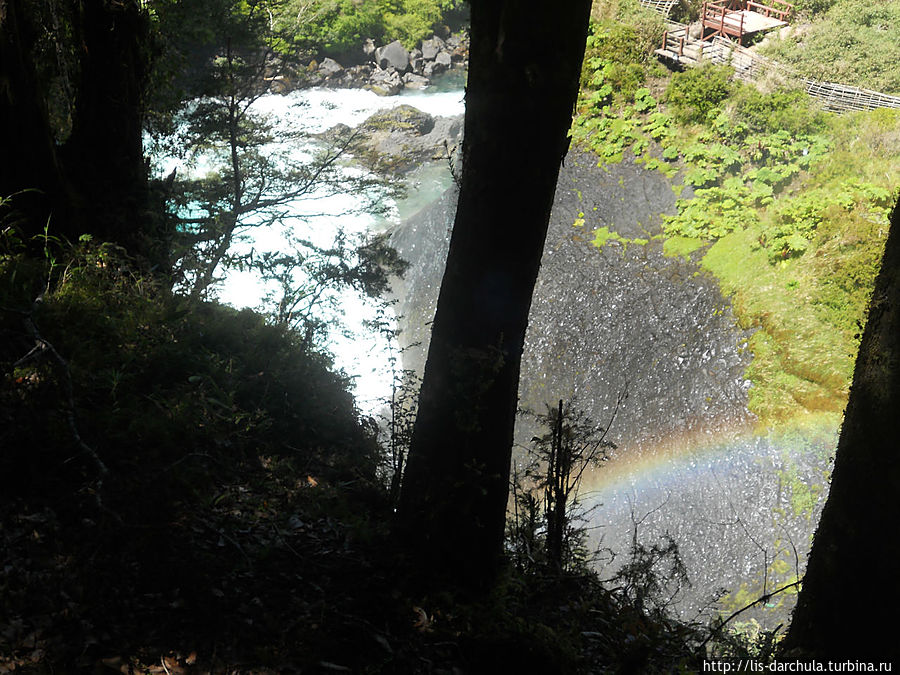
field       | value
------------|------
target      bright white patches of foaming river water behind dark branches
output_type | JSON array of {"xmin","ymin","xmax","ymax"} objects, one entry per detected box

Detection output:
[{"xmin": 149, "ymin": 87, "xmax": 464, "ymax": 414}]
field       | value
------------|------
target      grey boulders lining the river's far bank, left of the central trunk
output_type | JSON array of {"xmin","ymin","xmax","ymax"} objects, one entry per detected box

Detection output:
[{"xmin": 266, "ymin": 32, "xmax": 469, "ymax": 96}]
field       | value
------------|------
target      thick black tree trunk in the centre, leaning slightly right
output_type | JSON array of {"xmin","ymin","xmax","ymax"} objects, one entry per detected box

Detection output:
[{"xmin": 399, "ymin": 0, "xmax": 591, "ymax": 588}]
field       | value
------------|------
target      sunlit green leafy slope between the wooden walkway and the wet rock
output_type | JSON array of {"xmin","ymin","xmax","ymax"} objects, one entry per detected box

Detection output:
[{"xmin": 572, "ymin": 2, "xmax": 900, "ymax": 423}]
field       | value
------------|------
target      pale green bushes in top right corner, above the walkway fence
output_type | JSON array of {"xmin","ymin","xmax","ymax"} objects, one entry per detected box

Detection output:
[{"xmin": 764, "ymin": 0, "xmax": 900, "ymax": 94}]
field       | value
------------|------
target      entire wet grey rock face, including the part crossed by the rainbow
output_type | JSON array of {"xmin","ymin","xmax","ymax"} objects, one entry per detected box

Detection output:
[{"xmin": 391, "ymin": 152, "xmax": 834, "ymax": 628}]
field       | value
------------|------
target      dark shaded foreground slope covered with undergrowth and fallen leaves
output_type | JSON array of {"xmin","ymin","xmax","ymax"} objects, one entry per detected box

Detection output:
[{"xmin": 0, "ymin": 230, "xmax": 728, "ymax": 675}]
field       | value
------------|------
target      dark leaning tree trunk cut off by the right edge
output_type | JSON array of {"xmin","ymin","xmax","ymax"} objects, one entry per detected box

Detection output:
[{"xmin": 784, "ymin": 195, "xmax": 900, "ymax": 661}]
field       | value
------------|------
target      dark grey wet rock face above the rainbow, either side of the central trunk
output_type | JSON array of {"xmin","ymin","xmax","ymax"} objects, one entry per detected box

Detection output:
[{"xmin": 392, "ymin": 153, "xmax": 750, "ymax": 446}]
